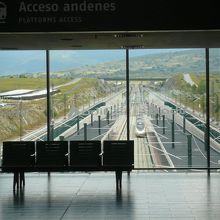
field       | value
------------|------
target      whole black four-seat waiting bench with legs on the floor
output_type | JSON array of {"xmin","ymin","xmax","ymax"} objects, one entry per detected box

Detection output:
[{"xmin": 1, "ymin": 141, "xmax": 134, "ymax": 190}]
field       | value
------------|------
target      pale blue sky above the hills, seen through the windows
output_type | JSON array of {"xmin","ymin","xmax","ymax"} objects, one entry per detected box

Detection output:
[{"xmin": 0, "ymin": 49, "xmax": 189, "ymax": 76}]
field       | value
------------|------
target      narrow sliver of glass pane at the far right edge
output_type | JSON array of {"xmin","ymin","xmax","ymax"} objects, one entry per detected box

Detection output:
[{"xmin": 209, "ymin": 48, "xmax": 220, "ymax": 168}]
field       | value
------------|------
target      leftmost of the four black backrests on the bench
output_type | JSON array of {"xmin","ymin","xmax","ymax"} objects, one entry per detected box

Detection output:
[{"xmin": 2, "ymin": 141, "xmax": 35, "ymax": 167}]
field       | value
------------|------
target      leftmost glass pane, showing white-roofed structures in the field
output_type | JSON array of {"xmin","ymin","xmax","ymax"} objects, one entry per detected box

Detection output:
[{"xmin": 0, "ymin": 51, "xmax": 46, "ymax": 162}]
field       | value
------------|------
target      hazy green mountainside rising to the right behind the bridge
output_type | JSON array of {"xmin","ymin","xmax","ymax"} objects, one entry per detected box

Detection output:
[{"xmin": 65, "ymin": 49, "xmax": 220, "ymax": 78}]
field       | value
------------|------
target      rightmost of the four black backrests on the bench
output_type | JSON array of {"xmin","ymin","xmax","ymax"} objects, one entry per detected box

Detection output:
[{"xmin": 103, "ymin": 140, "xmax": 134, "ymax": 167}]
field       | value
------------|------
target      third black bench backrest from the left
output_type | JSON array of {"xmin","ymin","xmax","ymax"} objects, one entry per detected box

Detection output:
[{"xmin": 70, "ymin": 141, "xmax": 101, "ymax": 167}]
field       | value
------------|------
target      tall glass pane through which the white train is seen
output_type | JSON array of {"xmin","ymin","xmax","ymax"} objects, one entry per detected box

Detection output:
[{"xmin": 130, "ymin": 49, "xmax": 207, "ymax": 169}]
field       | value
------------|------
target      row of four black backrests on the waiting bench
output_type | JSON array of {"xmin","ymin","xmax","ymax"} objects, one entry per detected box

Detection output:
[{"xmin": 3, "ymin": 140, "xmax": 134, "ymax": 168}]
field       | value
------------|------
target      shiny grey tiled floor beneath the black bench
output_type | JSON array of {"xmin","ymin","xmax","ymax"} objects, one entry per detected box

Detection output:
[{"xmin": 0, "ymin": 171, "xmax": 220, "ymax": 220}]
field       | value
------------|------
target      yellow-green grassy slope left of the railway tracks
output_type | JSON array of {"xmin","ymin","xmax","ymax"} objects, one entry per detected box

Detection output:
[{"xmin": 0, "ymin": 78, "xmax": 109, "ymax": 142}]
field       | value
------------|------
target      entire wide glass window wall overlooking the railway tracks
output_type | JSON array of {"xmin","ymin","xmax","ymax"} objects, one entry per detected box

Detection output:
[{"xmin": 0, "ymin": 48, "xmax": 220, "ymax": 169}]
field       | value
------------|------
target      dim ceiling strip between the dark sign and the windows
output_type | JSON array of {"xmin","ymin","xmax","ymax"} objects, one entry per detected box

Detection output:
[{"xmin": 0, "ymin": 30, "xmax": 220, "ymax": 50}]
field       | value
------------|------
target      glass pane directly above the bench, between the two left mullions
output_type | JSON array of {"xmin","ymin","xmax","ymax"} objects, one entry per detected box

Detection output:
[{"xmin": 50, "ymin": 50, "xmax": 126, "ymax": 140}]
